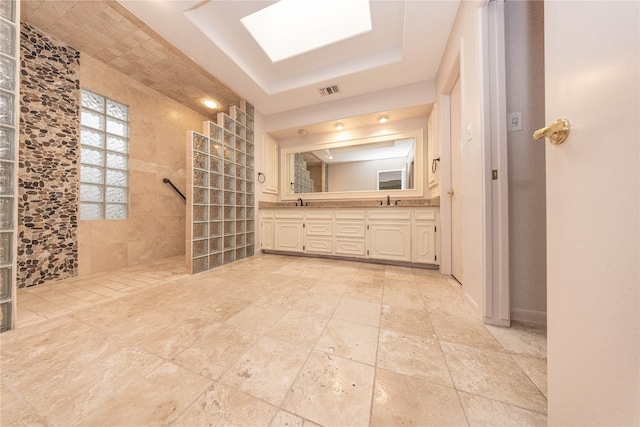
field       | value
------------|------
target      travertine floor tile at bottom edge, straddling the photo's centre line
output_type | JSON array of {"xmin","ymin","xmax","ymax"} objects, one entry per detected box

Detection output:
[{"xmin": 282, "ymin": 351, "xmax": 374, "ymax": 427}]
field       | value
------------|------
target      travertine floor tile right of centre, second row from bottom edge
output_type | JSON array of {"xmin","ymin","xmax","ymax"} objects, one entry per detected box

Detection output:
[{"xmin": 377, "ymin": 329, "xmax": 453, "ymax": 387}]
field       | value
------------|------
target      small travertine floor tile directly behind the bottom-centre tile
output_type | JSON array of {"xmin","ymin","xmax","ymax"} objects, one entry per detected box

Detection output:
[{"xmin": 316, "ymin": 319, "xmax": 378, "ymax": 365}]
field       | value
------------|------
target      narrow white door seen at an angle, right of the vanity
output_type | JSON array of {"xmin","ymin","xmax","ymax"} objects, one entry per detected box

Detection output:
[{"xmin": 449, "ymin": 79, "xmax": 463, "ymax": 283}]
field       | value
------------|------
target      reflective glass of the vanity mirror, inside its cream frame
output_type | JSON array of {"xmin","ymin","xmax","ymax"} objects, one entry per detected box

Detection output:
[{"xmin": 289, "ymin": 138, "xmax": 415, "ymax": 193}]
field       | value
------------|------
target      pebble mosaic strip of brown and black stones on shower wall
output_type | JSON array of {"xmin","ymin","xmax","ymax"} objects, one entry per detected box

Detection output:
[{"xmin": 17, "ymin": 23, "xmax": 80, "ymax": 288}]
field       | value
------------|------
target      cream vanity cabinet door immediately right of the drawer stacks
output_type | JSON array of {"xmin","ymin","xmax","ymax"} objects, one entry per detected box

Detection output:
[{"xmin": 367, "ymin": 221, "xmax": 411, "ymax": 261}]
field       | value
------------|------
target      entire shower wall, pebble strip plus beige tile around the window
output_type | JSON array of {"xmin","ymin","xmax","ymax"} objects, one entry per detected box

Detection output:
[{"xmin": 19, "ymin": 26, "xmax": 207, "ymax": 286}]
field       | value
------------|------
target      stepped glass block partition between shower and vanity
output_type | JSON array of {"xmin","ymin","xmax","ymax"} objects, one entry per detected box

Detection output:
[{"xmin": 186, "ymin": 101, "xmax": 255, "ymax": 274}]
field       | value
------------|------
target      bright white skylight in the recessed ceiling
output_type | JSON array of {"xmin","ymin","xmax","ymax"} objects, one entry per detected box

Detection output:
[{"xmin": 240, "ymin": 0, "xmax": 372, "ymax": 62}]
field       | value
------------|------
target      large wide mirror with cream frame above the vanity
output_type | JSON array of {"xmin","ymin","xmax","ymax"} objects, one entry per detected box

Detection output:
[{"xmin": 280, "ymin": 129, "xmax": 424, "ymax": 200}]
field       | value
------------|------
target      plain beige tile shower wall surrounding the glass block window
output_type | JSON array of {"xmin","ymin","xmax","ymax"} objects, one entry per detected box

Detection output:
[{"xmin": 78, "ymin": 53, "xmax": 207, "ymax": 275}]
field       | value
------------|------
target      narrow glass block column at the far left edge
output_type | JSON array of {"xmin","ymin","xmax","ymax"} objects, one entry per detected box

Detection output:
[{"xmin": 0, "ymin": 0, "xmax": 20, "ymax": 332}]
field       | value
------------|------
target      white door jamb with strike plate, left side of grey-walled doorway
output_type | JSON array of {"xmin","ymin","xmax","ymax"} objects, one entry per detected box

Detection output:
[{"xmin": 478, "ymin": 0, "xmax": 511, "ymax": 326}]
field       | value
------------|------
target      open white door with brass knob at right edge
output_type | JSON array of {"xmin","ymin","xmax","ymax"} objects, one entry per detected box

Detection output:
[{"xmin": 538, "ymin": 1, "xmax": 640, "ymax": 426}]
